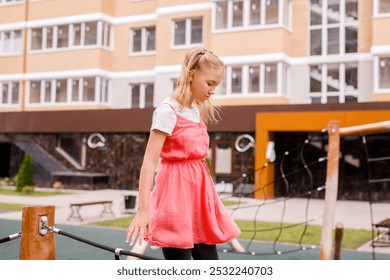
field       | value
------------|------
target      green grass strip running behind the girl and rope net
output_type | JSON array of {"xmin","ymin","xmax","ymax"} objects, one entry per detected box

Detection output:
[{"xmin": 91, "ymin": 216, "xmax": 371, "ymax": 249}]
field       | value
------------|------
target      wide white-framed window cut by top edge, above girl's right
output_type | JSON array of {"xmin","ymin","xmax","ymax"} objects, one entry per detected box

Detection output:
[{"xmin": 214, "ymin": 0, "xmax": 291, "ymax": 30}]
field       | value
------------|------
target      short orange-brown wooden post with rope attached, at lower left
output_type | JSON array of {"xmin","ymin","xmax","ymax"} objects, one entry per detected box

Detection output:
[{"xmin": 19, "ymin": 206, "xmax": 55, "ymax": 260}]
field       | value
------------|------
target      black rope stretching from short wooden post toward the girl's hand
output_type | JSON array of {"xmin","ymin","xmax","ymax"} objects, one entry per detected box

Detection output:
[{"xmin": 43, "ymin": 224, "xmax": 159, "ymax": 260}]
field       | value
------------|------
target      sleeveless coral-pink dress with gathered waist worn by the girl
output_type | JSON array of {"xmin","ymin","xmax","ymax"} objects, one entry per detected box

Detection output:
[{"xmin": 145, "ymin": 109, "xmax": 241, "ymax": 249}]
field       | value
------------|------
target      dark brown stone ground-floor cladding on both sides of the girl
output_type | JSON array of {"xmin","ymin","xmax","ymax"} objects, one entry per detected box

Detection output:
[{"xmin": 0, "ymin": 133, "xmax": 254, "ymax": 190}]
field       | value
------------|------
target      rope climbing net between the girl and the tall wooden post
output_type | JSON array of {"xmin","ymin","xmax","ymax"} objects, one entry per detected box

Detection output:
[{"xmin": 220, "ymin": 131, "xmax": 327, "ymax": 255}]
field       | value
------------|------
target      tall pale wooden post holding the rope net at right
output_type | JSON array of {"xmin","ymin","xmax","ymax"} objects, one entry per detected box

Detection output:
[{"xmin": 320, "ymin": 121, "xmax": 340, "ymax": 260}]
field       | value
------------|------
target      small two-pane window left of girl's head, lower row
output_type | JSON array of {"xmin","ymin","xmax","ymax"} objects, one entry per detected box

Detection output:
[{"xmin": 129, "ymin": 83, "xmax": 154, "ymax": 108}]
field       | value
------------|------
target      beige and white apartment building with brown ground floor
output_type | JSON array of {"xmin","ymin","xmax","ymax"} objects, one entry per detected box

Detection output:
[{"xmin": 0, "ymin": 0, "xmax": 390, "ymax": 195}]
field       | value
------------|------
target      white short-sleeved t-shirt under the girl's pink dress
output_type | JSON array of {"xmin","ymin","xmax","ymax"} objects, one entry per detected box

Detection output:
[{"xmin": 150, "ymin": 97, "xmax": 200, "ymax": 135}]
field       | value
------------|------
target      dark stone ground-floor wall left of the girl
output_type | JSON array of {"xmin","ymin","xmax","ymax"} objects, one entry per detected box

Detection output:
[{"xmin": 0, "ymin": 133, "xmax": 148, "ymax": 189}]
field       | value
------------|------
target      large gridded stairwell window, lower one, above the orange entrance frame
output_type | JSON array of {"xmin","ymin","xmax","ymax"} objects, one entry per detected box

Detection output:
[{"xmin": 310, "ymin": 63, "xmax": 358, "ymax": 103}]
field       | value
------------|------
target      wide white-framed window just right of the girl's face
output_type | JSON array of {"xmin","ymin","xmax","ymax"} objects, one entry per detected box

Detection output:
[{"xmin": 221, "ymin": 62, "xmax": 288, "ymax": 96}]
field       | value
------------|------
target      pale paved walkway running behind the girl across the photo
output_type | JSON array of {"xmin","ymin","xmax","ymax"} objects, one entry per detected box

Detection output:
[{"xmin": 0, "ymin": 189, "xmax": 390, "ymax": 254}]
